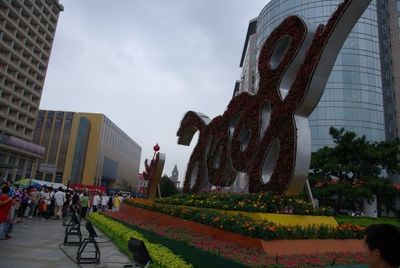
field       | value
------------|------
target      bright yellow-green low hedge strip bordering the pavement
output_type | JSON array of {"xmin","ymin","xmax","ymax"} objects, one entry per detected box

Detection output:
[{"xmin": 88, "ymin": 213, "xmax": 193, "ymax": 267}]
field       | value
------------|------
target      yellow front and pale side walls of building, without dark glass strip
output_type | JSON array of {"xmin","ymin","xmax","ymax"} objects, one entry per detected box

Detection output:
[{"xmin": 58, "ymin": 113, "xmax": 142, "ymax": 190}]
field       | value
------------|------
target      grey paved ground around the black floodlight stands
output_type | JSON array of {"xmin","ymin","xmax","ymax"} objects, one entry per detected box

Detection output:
[{"xmin": 0, "ymin": 218, "xmax": 131, "ymax": 268}]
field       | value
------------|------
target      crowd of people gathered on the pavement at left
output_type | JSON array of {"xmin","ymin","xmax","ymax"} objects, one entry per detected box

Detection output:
[{"xmin": 0, "ymin": 181, "xmax": 134, "ymax": 240}]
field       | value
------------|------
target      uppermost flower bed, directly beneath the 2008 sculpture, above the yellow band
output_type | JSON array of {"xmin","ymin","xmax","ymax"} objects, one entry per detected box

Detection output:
[{"xmin": 155, "ymin": 193, "xmax": 334, "ymax": 216}]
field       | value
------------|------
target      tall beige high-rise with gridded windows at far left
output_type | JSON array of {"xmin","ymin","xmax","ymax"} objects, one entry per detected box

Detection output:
[{"xmin": 0, "ymin": 0, "xmax": 63, "ymax": 180}]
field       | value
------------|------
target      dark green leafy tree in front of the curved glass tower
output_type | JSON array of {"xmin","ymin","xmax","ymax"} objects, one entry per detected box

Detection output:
[{"xmin": 310, "ymin": 127, "xmax": 400, "ymax": 214}]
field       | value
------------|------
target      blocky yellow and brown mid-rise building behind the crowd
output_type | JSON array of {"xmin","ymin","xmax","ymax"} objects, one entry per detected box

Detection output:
[{"xmin": 33, "ymin": 110, "xmax": 142, "ymax": 190}]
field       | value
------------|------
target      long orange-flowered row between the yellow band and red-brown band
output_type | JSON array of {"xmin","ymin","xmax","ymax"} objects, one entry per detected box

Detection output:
[{"xmin": 125, "ymin": 199, "xmax": 365, "ymax": 240}]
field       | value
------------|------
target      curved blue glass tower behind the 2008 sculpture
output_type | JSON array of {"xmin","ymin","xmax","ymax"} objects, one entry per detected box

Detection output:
[{"xmin": 257, "ymin": 0, "xmax": 385, "ymax": 151}]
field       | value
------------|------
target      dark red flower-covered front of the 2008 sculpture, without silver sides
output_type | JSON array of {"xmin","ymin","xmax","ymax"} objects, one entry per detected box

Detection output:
[{"xmin": 177, "ymin": 0, "xmax": 351, "ymax": 195}]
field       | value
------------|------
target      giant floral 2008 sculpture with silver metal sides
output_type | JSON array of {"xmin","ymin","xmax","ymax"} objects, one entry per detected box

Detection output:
[{"xmin": 177, "ymin": 0, "xmax": 371, "ymax": 195}]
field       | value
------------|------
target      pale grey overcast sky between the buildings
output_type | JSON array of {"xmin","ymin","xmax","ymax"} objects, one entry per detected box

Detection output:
[{"xmin": 40, "ymin": 0, "xmax": 269, "ymax": 180}]
